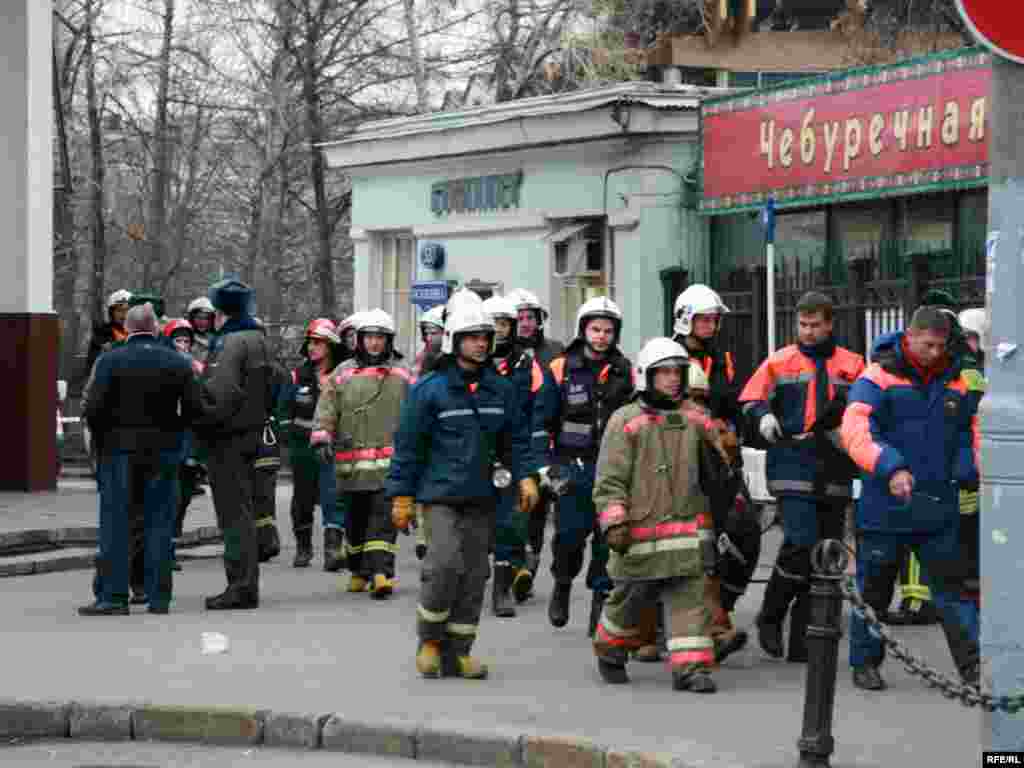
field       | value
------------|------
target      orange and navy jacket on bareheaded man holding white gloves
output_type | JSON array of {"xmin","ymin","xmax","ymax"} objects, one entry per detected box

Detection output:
[{"xmin": 739, "ymin": 340, "xmax": 864, "ymax": 499}]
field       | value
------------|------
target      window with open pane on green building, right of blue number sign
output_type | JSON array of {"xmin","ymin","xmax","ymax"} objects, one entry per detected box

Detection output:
[{"xmin": 548, "ymin": 219, "xmax": 615, "ymax": 340}]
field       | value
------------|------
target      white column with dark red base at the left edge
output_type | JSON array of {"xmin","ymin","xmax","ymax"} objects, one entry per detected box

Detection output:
[{"xmin": 0, "ymin": 0, "xmax": 60, "ymax": 492}]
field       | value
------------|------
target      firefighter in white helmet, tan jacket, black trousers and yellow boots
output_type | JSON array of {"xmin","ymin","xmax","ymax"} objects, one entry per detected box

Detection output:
[{"xmin": 310, "ymin": 309, "xmax": 413, "ymax": 599}]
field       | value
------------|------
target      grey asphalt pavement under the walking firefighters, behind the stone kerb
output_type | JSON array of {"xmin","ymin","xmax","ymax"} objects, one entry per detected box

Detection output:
[{"xmin": 0, "ymin": 485, "xmax": 981, "ymax": 768}]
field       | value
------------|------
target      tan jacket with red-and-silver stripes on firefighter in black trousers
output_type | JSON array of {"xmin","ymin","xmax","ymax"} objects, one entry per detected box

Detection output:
[{"xmin": 309, "ymin": 357, "xmax": 413, "ymax": 492}]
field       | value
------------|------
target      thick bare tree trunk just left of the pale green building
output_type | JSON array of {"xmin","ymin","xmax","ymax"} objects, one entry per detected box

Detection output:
[{"xmin": 302, "ymin": 11, "xmax": 337, "ymax": 317}]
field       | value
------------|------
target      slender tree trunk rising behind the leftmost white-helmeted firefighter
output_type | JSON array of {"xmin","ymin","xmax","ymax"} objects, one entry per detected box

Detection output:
[{"xmin": 84, "ymin": 0, "xmax": 106, "ymax": 333}]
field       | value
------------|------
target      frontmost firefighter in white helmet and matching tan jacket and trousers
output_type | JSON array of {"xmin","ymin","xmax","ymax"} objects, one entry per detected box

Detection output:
[{"xmin": 594, "ymin": 338, "xmax": 722, "ymax": 693}]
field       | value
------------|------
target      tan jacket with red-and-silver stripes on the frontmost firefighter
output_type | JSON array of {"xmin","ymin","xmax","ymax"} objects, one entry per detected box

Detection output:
[{"xmin": 594, "ymin": 400, "xmax": 714, "ymax": 581}]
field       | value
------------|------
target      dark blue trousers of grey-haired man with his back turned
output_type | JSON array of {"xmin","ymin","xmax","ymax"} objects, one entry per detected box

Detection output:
[{"xmin": 93, "ymin": 451, "xmax": 180, "ymax": 607}]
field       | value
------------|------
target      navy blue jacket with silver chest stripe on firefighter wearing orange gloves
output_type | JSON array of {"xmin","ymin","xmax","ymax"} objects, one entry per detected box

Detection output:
[{"xmin": 386, "ymin": 355, "xmax": 539, "ymax": 506}]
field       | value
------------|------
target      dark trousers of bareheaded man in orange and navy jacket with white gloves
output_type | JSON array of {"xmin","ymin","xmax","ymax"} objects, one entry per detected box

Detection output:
[{"xmin": 760, "ymin": 496, "xmax": 850, "ymax": 625}]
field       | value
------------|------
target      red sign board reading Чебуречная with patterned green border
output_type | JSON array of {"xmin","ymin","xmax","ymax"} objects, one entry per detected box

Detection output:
[{"xmin": 700, "ymin": 48, "xmax": 991, "ymax": 214}]
